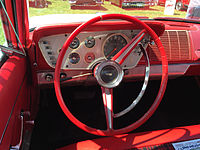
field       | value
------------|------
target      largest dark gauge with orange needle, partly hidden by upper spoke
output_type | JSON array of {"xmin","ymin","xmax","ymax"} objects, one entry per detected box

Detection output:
[{"xmin": 103, "ymin": 34, "xmax": 127, "ymax": 59}]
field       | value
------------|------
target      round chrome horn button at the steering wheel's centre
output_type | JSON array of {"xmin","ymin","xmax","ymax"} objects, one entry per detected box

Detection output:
[{"xmin": 94, "ymin": 60, "xmax": 124, "ymax": 88}]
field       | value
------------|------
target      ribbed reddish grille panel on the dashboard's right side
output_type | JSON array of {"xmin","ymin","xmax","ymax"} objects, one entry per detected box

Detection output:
[{"xmin": 149, "ymin": 30, "xmax": 191, "ymax": 61}]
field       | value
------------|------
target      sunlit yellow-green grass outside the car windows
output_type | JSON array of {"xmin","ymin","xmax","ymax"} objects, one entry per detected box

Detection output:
[{"xmin": 0, "ymin": 0, "xmax": 186, "ymax": 44}]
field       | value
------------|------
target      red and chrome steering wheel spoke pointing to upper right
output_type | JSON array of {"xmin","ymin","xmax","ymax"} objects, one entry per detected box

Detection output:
[{"xmin": 112, "ymin": 29, "xmax": 146, "ymax": 65}]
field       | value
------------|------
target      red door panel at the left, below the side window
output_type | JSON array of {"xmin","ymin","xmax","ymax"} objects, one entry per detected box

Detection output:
[{"xmin": 0, "ymin": 56, "xmax": 29, "ymax": 150}]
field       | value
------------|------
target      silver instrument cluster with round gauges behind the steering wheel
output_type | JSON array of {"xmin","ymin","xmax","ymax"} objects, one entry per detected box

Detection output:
[{"xmin": 38, "ymin": 30, "xmax": 149, "ymax": 70}]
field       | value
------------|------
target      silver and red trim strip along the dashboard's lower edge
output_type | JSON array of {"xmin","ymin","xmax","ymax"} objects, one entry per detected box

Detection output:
[{"xmin": 37, "ymin": 63, "xmax": 200, "ymax": 85}]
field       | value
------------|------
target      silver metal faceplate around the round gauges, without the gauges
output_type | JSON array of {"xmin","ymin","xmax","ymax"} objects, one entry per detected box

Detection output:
[{"xmin": 38, "ymin": 30, "xmax": 147, "ymax": 70}]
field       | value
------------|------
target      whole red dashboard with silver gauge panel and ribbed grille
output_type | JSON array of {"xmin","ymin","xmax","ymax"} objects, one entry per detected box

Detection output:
[{"xmin": 29, "ymin": 20, "xmax": 200, "ymax": 85}]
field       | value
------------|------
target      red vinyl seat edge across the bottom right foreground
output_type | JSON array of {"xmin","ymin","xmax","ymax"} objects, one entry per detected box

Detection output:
[{"xmin": 57, "ymin": 125, "xmax": 200, "ymax": 150}]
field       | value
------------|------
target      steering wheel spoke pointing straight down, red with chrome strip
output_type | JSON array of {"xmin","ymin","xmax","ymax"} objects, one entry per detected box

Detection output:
[{"xmin": 101, "ymin": 87, "xmax": 113, "ymax": 130}]
